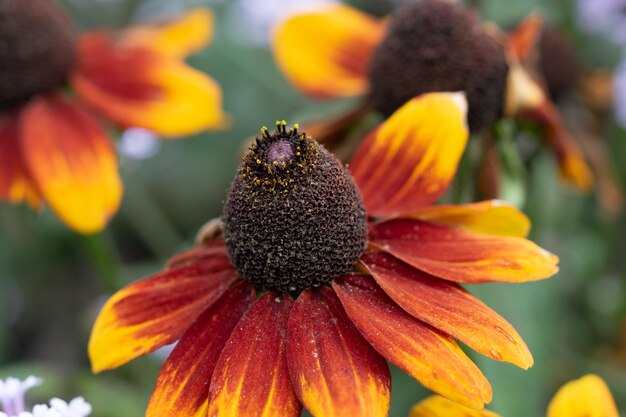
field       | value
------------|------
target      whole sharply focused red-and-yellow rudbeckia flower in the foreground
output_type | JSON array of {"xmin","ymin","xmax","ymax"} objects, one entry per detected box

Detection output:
[{"xmin": 89, "ymin": 93, "xmax": 557, "ymax": 417}]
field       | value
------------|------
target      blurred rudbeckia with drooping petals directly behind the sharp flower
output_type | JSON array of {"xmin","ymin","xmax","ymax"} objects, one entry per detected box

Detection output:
[{"xmin": 272, "ymin": 0, "xmax": 593, "ymax": 190}]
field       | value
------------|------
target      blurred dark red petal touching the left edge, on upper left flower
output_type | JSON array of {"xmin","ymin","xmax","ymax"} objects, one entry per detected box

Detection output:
[{"xmin": 0, "ymin": 115, "xmax": 41, "ymax": 208}]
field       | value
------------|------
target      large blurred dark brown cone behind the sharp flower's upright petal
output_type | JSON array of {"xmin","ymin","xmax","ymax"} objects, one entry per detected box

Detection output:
[{"xmin": 369, "ymin": 0, "xmax": 508, "ymax": 131}]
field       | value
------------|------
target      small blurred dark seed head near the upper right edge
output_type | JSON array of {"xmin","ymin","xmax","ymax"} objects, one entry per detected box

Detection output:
[{"xmin": 539, "ymin": 27, "xmax": 582, "ymax": 100}]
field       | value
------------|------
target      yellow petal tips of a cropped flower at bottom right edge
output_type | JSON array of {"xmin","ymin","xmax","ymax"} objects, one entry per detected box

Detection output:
[{"xmin": 409, "ymin": 374, "xmax": 619, "ymax": 417}]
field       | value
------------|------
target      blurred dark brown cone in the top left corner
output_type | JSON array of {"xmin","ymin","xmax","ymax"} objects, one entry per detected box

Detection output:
[{"xmin": 0, "ymin": 0, "xmax": 76, "ymax": 110}]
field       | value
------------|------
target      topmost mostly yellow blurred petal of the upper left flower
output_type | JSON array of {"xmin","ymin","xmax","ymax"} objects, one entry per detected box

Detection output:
[{"xmin": 120, "ymin": 7, "xmax": 213, "ymax": 58}]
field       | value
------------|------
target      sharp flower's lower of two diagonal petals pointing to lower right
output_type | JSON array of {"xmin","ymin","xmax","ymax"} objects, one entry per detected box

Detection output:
[{"xmin": 333, "ymin": 274, "xmax": 491, "ymax": 408}]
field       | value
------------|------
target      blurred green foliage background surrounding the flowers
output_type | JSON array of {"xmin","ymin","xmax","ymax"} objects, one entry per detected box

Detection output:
[{"xmin": 0, "ymin": 0, "xmax": 626, "ymax": 417}]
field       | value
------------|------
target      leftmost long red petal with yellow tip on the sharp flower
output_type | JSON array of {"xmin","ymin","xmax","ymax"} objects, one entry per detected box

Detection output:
[{"xmin": 89, "ymin": 255, "xmax": 237, "ymax": 372}]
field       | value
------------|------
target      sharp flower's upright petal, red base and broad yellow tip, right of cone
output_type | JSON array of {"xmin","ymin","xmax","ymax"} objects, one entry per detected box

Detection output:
[{"xmin": 350, "ymin": 93, "xmax": 468, "ymax": 216}]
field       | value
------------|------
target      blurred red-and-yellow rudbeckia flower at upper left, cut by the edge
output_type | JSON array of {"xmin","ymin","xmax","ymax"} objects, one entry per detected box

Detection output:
[{"xmin": 0, "ymin": 0, "xmax": 224, "ymax": 233}]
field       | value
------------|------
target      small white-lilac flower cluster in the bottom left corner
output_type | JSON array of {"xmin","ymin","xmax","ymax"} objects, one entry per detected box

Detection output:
[{"xmin": 0, "ymin": 376, "xmax": 91, "ymax": 417}]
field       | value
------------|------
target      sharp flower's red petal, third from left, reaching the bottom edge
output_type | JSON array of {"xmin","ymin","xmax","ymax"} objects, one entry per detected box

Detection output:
[{"xmin": 207, "ymin": 292, "xmax": 302, "ymax": 417}]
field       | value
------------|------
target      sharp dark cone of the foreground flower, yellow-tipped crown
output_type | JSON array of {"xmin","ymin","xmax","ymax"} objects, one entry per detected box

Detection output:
[{"xmin": 224, "ymin": 122, "xmax": 367, "ymax": 292}]
